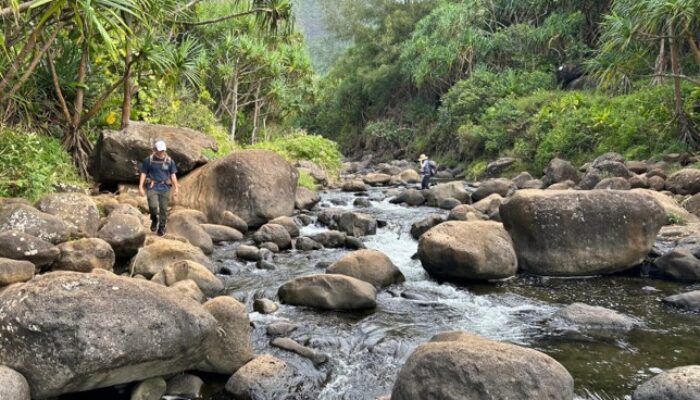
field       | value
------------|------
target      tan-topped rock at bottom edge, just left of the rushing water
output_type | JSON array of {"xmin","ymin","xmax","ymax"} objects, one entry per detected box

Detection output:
[{"xmin": 226, "ymin": 354, "xmax": 296, "ymax": 400}]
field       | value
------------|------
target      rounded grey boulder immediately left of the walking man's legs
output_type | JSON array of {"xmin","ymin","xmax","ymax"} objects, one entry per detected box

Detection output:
[{"xmin": 97, "ymin": 212, "xmax": 146, "ymax": 258}]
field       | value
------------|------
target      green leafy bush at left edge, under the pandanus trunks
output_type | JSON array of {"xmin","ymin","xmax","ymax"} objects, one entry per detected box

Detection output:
[{"xmin": 0, "ymin": 127, "xmax": 86, "ymax": 201}]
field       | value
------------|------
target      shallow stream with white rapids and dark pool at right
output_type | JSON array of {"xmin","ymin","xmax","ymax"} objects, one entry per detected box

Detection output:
[{"xmin": 60, "ymin": 189, "xmax": 700, "ymax": 400}]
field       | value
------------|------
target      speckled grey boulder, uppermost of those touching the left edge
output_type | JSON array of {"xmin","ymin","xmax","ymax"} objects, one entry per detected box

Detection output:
[{"xmin": 0, "ymin": 203, "xmax": 72, "ymax": 244}]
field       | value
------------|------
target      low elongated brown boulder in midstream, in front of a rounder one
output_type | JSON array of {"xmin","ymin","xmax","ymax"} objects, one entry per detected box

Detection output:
[{"xmin": 277, "ymin": 274, "xmax": 377, "ymax": 311}]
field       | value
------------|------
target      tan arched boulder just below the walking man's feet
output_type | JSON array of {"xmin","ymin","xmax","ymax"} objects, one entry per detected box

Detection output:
[{"xmin": 131, "ymin": 238, "xmax": 215, "ymax": 278}]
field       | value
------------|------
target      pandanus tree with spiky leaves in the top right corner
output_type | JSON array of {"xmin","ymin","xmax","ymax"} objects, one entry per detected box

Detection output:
[{"xmin": 592, "ymin": 0, "xmax": 700, "ymax": 147}]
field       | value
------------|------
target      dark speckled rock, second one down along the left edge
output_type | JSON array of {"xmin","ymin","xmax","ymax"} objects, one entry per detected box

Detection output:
[{"xmin": 0, "ymin": 230, "xmax": 61, "ymax": 267}]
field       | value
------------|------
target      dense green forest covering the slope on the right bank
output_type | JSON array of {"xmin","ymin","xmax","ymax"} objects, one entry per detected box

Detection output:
[{"xmin": 305, "ymin": 0, "xmax": 700, "ymax": 175}]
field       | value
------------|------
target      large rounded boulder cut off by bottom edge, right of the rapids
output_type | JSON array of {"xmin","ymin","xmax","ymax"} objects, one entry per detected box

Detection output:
[{"xmin": 391, "ymin": 332, "xmax": 574, "ymax": 400}]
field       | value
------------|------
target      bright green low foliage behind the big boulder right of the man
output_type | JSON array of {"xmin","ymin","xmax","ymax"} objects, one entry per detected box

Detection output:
[{"xmin": 246, "ymin": 131, "xmax": 342, "ymax": 176}]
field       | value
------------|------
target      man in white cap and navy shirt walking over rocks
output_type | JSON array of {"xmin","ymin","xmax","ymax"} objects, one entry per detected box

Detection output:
[{"xmin": 139, "ymin": 140, "xmax": 179, "ymax": 236}]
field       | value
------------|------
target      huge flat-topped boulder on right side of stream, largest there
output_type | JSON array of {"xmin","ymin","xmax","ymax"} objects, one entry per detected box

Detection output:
[{"xmin": 500, "ymin": 190, "xmax": 666, "ymax": 276}]
